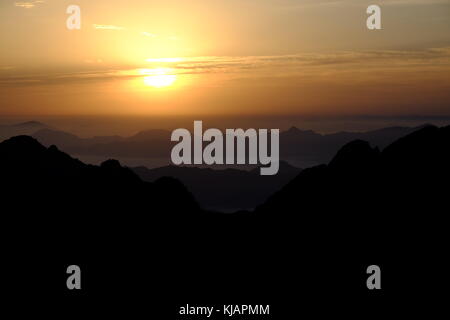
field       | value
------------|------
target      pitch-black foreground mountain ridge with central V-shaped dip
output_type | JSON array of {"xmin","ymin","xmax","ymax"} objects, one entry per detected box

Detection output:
[{"xmin": 0, "ymin": 126, "xmax": 450, "ymax": 319}]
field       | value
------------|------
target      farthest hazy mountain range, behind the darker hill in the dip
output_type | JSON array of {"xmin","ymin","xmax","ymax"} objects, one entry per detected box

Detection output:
[{"xmin": 0, "ymin": 122, "xmax": 423, "ymax": 168}]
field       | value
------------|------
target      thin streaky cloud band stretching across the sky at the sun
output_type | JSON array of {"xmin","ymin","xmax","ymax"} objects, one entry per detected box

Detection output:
[{"xmin": 0, "ymin": 47, "xmax": 450, "ymax": 86}]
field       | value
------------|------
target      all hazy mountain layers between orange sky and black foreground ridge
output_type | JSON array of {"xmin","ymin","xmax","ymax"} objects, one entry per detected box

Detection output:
[{"xmin": 3, "ymin": 121, "xmax": 440, "ymax": 212}]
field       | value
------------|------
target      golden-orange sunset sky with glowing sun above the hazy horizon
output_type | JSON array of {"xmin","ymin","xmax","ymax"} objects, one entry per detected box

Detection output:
[{"xmin": 0, "ymin": 0, "xmax": 450, "ymax": 116}]
